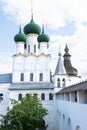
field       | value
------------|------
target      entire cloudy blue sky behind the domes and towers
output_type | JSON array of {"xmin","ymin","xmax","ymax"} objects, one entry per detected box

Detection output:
[{"xmin": 0, "ymin": 0, "xmax": 87, "ymax": 76}]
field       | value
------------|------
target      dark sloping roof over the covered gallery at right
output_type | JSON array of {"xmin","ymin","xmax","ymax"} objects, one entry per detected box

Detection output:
[{"xmin": 58, "ymin": 81, "xmax": 87, "ymax": 93}]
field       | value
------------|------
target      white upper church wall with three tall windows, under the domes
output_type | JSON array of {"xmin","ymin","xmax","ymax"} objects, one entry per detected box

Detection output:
[{"xmin": 12, "ymin": 55, "xmax": 50, "ymax": 82}]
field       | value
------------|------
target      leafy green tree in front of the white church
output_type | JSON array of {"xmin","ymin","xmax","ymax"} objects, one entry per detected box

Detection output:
[{"xmin": 0, "ymin": 94, "xmax": 48, "ymax": 130}]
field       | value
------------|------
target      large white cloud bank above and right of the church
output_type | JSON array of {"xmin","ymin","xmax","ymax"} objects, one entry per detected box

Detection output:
[{"xmin": 1, "ymin": 0, "xmax": 87, "ymax": 75}]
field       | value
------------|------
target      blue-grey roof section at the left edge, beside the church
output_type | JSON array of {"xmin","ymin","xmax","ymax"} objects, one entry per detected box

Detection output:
[{"xmin": 0, "ymin": 73, "xmax": 12, "ymax": 83}]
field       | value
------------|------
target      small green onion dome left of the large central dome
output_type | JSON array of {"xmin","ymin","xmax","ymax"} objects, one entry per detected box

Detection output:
[{"xmin": 14, "ymin": 26, "xmax": 26, "ymax": 42}]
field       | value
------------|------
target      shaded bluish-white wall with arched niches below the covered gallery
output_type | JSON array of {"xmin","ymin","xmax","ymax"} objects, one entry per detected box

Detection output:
[{"xmin": 56, "ymin": 100, "xmax": 87, "ymax": 130}]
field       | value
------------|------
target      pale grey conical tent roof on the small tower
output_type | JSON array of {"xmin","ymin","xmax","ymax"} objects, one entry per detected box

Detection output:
[{"xmin": 54, "ymin": 52, "xmax": 66, "ymax": 75}]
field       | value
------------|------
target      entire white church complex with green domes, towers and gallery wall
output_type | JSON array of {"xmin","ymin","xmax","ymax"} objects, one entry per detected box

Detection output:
[{"xmin": 0, "ymin": 5, "xmax": 87, "ymax": 130}]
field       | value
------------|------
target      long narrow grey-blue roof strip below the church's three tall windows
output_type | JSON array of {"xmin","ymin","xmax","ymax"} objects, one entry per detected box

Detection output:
[{"xmin": 9, "ymin": 82, "xmax": 54, "ymax": 90}]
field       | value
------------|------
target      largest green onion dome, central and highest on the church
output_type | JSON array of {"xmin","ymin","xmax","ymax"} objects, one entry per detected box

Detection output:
[{"xmin": 24, "ymin": 19, "xmax": 41, "ymax": 35}]
